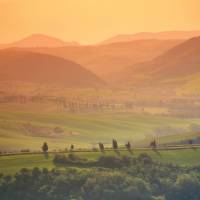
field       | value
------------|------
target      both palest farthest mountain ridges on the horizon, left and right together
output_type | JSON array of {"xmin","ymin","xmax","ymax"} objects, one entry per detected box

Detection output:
[{"xmin": 0, "ymin": 31, "xmax": 200, "ymax": 48}]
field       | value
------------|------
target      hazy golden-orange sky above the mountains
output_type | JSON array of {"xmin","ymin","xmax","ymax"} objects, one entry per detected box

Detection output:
[{"xmin": 0, "ymin": 0, "xmax": 200, "ymax": 44}]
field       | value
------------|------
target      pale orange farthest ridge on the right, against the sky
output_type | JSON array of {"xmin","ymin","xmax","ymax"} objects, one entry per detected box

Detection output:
[{"xmin": 99, "ymin": 31, "xmax": 200, "ymax": 45}]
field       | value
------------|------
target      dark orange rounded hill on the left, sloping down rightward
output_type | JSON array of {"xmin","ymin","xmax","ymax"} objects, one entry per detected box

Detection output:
[{"xmin": 0, "ymin": 49, "xmax": 103, "ymax": 87}]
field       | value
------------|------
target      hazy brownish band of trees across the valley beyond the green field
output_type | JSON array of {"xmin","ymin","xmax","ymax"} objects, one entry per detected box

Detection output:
[{"xmin": 0, "ymin": 95, "xmax": 138, "ymax": 112}]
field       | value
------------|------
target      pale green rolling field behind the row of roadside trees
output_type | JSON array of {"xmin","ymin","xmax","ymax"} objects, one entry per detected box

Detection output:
[{"xmin": 0, "ymin": 111, "xmax": 200, "ymax": 150}]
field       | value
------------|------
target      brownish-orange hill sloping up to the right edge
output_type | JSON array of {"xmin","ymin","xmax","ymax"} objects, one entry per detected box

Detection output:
[{"xmin": 119, "ymin": 37, "xmax": 200, "ymax": 87}]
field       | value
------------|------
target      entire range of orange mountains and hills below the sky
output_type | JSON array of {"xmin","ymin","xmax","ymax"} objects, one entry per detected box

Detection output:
[{"xmin": 0, "ymin": 31, "xmax": 200, "ymax": 91}]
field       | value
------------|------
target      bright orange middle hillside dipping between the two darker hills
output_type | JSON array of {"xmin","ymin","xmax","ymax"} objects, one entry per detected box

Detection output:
[{"xmin": 23, "ymin": 40, "xmax": 182, "ymax": 82}]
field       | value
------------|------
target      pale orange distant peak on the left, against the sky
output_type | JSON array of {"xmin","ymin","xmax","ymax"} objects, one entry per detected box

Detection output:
[{"xmin": 0, "ymin": 34, "xmax": 79, "ymax": 48}]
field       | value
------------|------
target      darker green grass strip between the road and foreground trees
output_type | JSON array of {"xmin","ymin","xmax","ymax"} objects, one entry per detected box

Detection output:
[{"xmin": 0, "ymin": 149, "xmax": 200, "ymax": 174}]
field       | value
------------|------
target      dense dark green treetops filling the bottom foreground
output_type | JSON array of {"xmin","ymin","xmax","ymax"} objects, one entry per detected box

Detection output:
[{"xmin": 0, "ymin": 154, "xmax": 200, "ymax": 200}]
